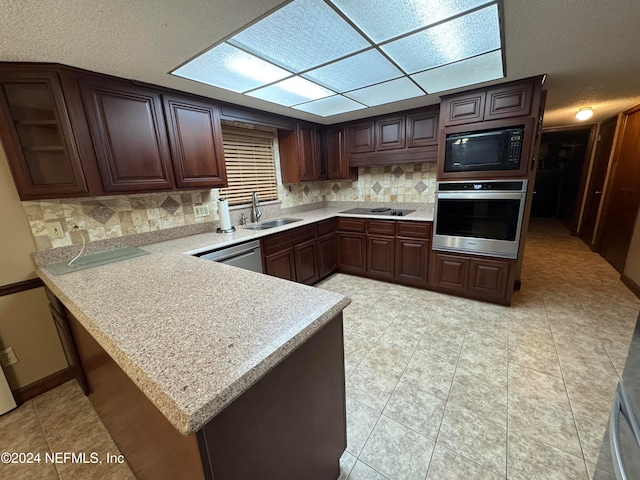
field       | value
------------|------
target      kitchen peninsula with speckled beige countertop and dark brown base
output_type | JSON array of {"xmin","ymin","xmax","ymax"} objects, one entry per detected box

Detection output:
[{"xmin": 38, "ymin": 216, "xmax": 349, "ymax": 480}]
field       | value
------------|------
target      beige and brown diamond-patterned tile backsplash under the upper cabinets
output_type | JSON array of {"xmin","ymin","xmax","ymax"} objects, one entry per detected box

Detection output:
[{"xmin": 22, "ymin": 163, "xmax": 436, "ymax": 251}]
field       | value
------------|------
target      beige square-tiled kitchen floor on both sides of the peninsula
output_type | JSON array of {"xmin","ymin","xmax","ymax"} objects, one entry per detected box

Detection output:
[{"xmin": 0, "ymin": 220, "xmax": 640, "ymax": 480}]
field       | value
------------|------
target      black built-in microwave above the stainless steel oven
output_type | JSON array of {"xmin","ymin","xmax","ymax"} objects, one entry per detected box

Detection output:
[{"xmin": 444, "ymin": 125, "xmax": 524, "ymax": 172}]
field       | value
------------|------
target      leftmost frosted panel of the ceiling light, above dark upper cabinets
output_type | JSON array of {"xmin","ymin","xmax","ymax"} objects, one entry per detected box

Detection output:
[{"xmin": 171, "ymin": 43, "xmax": 291, "ymax": 92}]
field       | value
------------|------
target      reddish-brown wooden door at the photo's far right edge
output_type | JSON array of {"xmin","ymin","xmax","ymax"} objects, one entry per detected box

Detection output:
[{"xmin": 598, "ymin": 105, "xmax": 640, "ymax": 272}]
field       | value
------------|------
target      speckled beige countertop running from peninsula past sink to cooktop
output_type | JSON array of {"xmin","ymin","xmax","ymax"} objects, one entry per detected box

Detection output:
[{"xmin": 37, "ymin": 208, "xmax": 433, "ymax": 435}]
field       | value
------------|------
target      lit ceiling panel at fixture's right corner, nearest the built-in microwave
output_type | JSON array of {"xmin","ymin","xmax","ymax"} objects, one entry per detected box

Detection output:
[{"xmin": 411, "ymin": 50, "xmax": 504, "ymax": 93}]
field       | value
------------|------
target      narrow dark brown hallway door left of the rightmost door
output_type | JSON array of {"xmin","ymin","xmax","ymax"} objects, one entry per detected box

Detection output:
[{"xmin": 580, "ymin": 117, "xmax": 618, "ymax": 250}]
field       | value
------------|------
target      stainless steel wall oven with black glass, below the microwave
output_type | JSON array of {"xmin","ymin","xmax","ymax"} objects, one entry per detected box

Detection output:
[{"xmin": 433, "ymin": 180, "xmax": 527, "ymax": 258}]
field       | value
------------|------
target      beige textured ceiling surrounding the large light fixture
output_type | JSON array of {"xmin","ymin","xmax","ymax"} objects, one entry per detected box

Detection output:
[{"xmin": 0, "ymin": 0, "xmax": 640, "ymax": 127}]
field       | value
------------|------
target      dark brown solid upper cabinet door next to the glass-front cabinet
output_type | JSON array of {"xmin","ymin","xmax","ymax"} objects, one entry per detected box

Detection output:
[{"xmin": 81, "ymin": 76, "xmax": 175, "ymax": 192}]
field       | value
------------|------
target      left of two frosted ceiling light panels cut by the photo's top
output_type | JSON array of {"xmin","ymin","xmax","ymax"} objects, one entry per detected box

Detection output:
[{"xmin": 228, "ymin": 0, "xmax": 371, "ymax": 72}]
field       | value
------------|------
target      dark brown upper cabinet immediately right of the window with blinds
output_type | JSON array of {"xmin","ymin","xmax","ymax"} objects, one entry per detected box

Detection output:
[{"xmin": 278, "ymin": 121, "xmax": 327, "ymax": 183}]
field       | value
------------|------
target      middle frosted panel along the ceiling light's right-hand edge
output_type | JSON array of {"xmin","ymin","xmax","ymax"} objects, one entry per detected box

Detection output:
[{"xmin": 382, "ymin": 5, "xmax": 501, "ymax": 74}]
